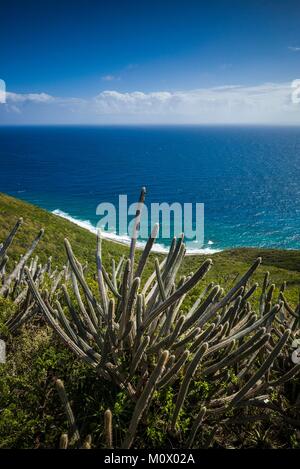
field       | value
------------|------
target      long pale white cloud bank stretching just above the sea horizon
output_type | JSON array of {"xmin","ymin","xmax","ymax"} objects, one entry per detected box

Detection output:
[{"xmin": 0, "ymin": 83, "xmax": 300, "ymax": 124}]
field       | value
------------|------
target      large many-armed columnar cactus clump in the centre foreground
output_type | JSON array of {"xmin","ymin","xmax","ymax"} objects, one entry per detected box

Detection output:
[{"xmin": 24, "ymin": 189, "xmax": 300, "ymax": 448}]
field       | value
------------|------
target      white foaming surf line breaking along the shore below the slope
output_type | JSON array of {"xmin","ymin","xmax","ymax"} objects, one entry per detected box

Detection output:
[{"xmin": 52, "ymin": 208, "xmax": 221, "ymax": 252}]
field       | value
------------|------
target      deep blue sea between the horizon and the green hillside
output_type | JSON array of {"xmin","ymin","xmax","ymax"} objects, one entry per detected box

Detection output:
[{"xmin": 0, "ymin": 126, "xmax": 300, "ymax": 250}]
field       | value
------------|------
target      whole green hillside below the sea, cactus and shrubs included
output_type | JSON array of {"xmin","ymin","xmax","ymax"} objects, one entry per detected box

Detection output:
[{"xmin": 0, "ymin": 194, "xmax": 300, "ymax": 448}]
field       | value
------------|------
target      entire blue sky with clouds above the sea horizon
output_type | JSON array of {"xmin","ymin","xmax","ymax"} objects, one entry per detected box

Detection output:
[{"xmin": 0, "ymin": 0, "xmax": 300, "ymax": 125}]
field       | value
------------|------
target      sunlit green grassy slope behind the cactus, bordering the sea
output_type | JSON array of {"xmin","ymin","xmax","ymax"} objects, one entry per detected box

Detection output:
[{"xmin": 0, "ymin": 193, "xmax": 300, "ymax": 305}]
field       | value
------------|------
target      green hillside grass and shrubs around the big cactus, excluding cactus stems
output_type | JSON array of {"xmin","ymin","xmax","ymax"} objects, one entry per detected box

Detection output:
[{"xmin": 0, "ymin": 194, "xmax": 300, "ymax": 449}]
